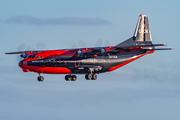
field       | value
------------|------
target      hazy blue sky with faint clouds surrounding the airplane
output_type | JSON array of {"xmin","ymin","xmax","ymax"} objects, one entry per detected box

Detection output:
[{"xmin": 0, "ymin": 0, "xmax": 180, "ymax": 120}]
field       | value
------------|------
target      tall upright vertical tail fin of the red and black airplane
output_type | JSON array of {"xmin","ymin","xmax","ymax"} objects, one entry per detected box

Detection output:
[{"xmin": 117, "ymin": 14, "xmax": 152, "ymax": 46}]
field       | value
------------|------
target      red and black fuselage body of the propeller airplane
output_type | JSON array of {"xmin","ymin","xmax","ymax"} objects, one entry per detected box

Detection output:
[{"xmin": 19, "ymin": 50, "xmax": 152, "ymax": 74}]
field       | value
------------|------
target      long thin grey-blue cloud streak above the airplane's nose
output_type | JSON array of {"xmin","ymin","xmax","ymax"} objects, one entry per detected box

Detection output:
[{"xmin": 4, "ymin": 16, "xmax": 111, "ymax": 26}]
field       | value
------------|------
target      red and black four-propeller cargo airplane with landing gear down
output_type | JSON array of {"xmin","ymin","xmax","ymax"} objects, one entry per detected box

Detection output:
[{"xmin": 5, "ymin": 14, "xmax": 172, "ymax": 81}]
